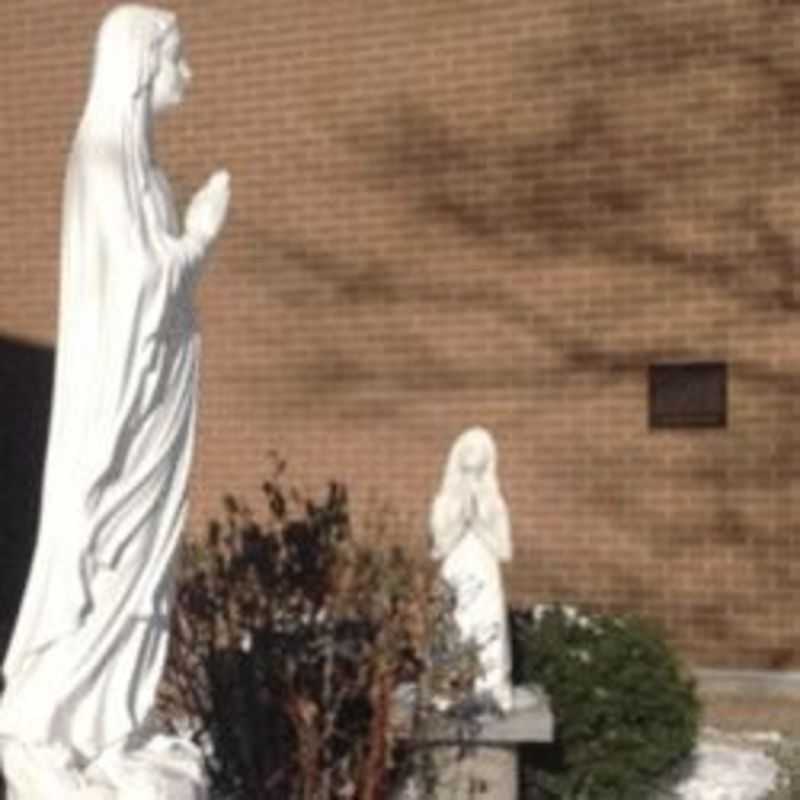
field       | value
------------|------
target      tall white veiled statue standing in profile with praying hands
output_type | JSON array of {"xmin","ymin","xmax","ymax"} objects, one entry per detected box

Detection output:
[{"xmin": 0, "ymin": 5, "xmax": 230, "ymax": 800}]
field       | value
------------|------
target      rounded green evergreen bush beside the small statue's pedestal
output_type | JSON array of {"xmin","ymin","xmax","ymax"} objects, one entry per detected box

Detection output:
[{"xmin": 512, "ymin": 606, "xmax": 700, "ymax": 800}]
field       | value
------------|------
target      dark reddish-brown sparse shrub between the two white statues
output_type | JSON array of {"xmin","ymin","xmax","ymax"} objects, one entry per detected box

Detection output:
[{"xmin": 160, "ymin": 467, "xmax": 475, "ymax": 800}]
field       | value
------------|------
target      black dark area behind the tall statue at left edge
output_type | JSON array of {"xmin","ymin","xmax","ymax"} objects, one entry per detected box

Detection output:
[{"xmin": 0, "ymin": 337, "xmax": 54, "ymax": 668}]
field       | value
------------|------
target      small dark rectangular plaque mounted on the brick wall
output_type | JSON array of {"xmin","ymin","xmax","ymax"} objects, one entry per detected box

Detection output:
[{"xmin": 649, "ymin": 362, "xmax": 728, "ymax": 428}]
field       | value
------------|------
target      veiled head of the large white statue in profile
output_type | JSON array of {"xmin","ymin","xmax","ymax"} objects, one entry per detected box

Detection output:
[{"xmin": 91, "ymin": 4, "xmax": 190, "ymax": 112}]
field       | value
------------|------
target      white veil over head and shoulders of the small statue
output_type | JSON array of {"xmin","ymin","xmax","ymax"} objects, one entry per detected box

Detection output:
[{"xmin": 430, "ymin": 427, "xmax": 511, "ymax": 561}]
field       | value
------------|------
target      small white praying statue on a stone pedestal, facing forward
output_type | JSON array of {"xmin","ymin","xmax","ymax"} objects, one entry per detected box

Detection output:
[{"xmin": 430, "ymin": 428, "xmax": 512, "ymax": 713}]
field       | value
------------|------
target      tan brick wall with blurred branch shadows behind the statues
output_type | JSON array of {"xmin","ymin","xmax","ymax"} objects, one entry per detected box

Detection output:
[{"xmin": 0, "ymin": 0, "xmax": 800, "ymax": 668}]
